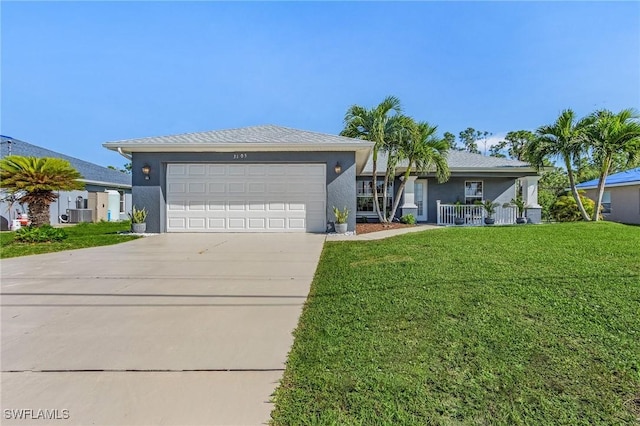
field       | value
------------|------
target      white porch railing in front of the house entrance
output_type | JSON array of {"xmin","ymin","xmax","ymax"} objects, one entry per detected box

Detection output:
[{"xmin": 436, "ymin": 200, "xmax": 517, "ymax": 226}]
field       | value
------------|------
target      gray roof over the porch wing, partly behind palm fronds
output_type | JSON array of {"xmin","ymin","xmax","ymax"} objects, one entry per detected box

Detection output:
[{"xmin": 363, "ymin": 150, "xmax": 535, "ymax": 174}]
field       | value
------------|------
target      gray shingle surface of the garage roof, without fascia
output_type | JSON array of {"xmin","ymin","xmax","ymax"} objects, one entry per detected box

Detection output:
[{"xmin": 104, "ymin": 125, "xmax": 370, "ymax": 148}]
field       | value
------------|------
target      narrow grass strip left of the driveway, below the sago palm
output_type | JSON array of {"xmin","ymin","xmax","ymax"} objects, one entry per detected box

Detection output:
[{"xmin": 0, "ymin": 221, "xmax": 138, "ymax": 259}]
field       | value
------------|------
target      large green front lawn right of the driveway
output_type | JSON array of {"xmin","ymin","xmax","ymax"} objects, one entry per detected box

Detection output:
[{"xmin": 272, "ymin": 222, "xmax": 640, "ymax": 425}]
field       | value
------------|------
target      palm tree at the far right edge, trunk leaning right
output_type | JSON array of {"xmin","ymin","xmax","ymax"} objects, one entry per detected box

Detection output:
[{"xmin": 589, "ymin": 109, "xmax": 640, "ymax": 221}]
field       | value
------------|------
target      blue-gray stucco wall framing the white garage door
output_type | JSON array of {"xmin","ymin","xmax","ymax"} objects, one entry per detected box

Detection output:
[{"xmin": 132, "ymin": 151, "xmax": 356, "ymax": 232}]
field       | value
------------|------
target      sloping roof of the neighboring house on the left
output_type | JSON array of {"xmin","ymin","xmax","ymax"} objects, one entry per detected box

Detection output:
[{"xmin": 0, "ymin": 136, "xmax": 131, "ymax": 188}]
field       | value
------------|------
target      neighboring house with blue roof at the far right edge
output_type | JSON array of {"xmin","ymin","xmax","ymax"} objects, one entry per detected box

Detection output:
[{"xmin": 576, "ymin": 167, "xmax": 640, "ymax": 224}]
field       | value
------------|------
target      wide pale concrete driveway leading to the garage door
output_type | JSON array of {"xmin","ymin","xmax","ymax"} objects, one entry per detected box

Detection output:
[{"xmin": 0, "ymin": 234, "xmax": 325, "ymax": 425}]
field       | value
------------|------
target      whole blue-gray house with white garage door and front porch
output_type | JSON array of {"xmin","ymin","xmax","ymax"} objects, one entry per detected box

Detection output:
[{"xmin": 104, "ymin": 125, "xmax": 540, "ymax": 232}]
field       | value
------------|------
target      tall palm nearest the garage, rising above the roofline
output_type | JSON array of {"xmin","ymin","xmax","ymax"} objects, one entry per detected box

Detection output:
[{"xmin": 340, "ymin": 96, "xmax": 402, "ymax": 222}]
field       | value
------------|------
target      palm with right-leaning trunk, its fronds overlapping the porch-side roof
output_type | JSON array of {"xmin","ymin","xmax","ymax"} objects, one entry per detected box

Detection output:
[{"xmin": 390, "ymin": 118, "xmax": 451, "ymax": 217}]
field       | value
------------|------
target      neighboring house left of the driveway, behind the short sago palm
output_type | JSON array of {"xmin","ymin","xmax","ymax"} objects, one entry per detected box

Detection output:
[{"xmin": 0, "ymin": 136, "xmax": 131, "ymax": 230}]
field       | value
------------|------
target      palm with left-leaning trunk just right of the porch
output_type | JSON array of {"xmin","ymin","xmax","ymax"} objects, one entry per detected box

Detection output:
[{"xmin": 526, "ymin": 109, "xmax": 593, "ymax": 221}]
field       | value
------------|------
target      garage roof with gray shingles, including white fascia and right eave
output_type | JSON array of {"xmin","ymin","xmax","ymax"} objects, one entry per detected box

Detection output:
[{"xmin": 103, "ymin": 125, "xmax": 373, "ymax": 170}]
